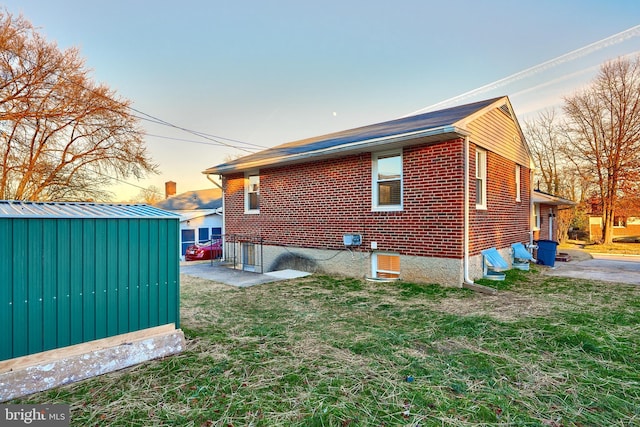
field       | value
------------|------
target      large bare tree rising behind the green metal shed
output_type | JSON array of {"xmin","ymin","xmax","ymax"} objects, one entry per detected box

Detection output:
[{"xmin": 0, "ymin": 12, "xmax": 157, "ymax": 200}]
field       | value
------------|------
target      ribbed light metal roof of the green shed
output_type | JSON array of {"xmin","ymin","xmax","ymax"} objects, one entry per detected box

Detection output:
[{"xmin": 0, "ymin": 200, "xmax": 180, "ymax": 219}]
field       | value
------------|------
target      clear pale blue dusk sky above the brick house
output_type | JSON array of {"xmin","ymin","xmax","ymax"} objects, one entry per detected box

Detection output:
[{"xmin": 4, "ymin": 0, "xmax": 640, "ymax": 201}]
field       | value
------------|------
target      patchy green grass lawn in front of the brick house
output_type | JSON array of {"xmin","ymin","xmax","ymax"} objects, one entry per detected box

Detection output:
[{"xmin": 11, "ymin": 268, "xmax": 640, "ymax": 427}]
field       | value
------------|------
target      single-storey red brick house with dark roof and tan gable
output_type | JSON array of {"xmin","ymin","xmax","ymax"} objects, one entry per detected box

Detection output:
[{"xmin": 203, "ymin": 97, "xmax": 532, "ymax": 286}]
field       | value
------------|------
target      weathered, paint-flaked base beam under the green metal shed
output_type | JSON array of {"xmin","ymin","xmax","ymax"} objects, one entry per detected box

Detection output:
[{"xmin": 0, "ymin": 324, "xmax": 185, "ymax": 402}]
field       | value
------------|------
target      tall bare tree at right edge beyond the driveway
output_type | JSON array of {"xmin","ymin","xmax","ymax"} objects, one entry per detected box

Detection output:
[{"xmin": 564, "ymin": 56, "xmax": 640, "ymax": 243}]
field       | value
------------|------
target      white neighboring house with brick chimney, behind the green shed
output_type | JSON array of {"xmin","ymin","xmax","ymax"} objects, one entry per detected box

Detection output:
[{"xmin": 154, "ymin": 186, "xmax": 222, "ymax": 260}]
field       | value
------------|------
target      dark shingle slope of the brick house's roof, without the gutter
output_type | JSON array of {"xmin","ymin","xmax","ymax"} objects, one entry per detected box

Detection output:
[{"xmin": 203, "ymin": 97, "xmax": 503, "ymax": 173}]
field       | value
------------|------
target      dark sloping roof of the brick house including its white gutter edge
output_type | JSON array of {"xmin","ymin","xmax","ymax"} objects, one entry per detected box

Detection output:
[{"xmin": 203, "ymin": 97, "xmax": 505, "ymax": 174}]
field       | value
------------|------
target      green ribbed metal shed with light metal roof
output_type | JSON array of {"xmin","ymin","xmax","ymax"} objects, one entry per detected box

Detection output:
[{"xmin": 0, "ymin": 201, "xmax": 180, "ymax": 361}]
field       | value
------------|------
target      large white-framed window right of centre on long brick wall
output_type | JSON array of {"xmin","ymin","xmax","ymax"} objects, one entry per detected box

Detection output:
[{"xmin": 372, "ymin": 151, "xmax": 402, "ymax": 211}]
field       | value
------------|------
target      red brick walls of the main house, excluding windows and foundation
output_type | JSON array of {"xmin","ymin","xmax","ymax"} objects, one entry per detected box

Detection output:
[{"xmin": 225, "ymin": 139, "xmax": 529, "ymax": 258}]
